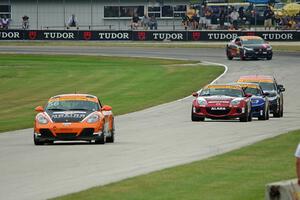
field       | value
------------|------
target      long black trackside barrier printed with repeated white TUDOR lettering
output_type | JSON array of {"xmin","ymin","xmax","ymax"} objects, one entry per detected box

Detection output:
[{"xmin": 0, "ymin": 30, "xmax": 300, "ymax": 41}]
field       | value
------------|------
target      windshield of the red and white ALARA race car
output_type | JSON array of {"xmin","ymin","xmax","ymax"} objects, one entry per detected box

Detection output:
[{"xmin": 200, "ymin": 88, "xmax": 244, "ymax": 97}]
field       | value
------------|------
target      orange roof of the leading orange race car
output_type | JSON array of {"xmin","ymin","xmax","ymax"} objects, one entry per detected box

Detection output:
[{"xmin": 49, "ymin": 94, "xmax": 98, "ymax": 103}]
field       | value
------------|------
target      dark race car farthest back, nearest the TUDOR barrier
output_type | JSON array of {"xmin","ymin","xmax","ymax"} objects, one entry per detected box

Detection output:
[{"xmin": 226, "ymin": 36, "xmax": 273, "ymax": 60}]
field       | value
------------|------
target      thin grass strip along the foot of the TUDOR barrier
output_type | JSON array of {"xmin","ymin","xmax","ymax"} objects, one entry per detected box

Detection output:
[{"xmin": 0, "ymin": 41, "xmax": 300, "ymax": 52}]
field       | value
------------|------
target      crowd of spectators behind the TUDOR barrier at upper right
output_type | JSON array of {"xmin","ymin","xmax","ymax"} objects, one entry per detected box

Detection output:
[{"xmin": 182, "ymin": 3, "xmax": 300, "ymax": 30}]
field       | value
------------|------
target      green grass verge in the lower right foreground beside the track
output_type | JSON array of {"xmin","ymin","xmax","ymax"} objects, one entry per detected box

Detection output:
[{"xmin": 57, "ymin": 131, "xmax": 300, "ymax": 200}]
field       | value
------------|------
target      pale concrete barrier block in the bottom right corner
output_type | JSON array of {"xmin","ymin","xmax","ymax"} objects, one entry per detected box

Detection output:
[{"xmin": 266, "ymin": 179, "xmax": 300, "ymax": 200}]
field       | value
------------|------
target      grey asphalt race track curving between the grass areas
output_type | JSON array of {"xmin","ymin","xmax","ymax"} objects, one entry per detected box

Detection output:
[{"xmin": 0, "ymin": 46, "xmax": 300, "ymax": 200}]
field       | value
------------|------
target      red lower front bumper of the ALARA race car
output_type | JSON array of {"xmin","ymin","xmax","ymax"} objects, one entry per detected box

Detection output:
[{"xmin": 193, "ymin": 107, "xmax": 246, "ymax": 119}]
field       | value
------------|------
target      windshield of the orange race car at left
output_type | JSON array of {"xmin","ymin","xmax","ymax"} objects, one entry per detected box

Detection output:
[{"xmin": 46, "ymin": 100, "xmax": 100, "ymax": 111}]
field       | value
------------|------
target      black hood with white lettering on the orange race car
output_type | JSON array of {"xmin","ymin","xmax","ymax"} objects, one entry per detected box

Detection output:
[{"xmin": 46, "ymin": 110, "xmax": 94, "ymax": 123}]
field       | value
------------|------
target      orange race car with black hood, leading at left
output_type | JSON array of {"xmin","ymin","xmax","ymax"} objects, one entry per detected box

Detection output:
[{"xmin": 33, "ymin": 94, "xmax": 115, "ymax": 145}]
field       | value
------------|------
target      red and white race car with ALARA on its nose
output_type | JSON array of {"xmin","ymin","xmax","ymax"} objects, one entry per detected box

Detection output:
[{"xmin": 191, "ymin": 84, "xmax": 252, "ymax": 122}]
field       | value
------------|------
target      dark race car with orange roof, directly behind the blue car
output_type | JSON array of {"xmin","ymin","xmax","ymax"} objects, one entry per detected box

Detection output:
[{"xmin": 237, "ymin": 75, "xmax": 285, "ymax": 117}]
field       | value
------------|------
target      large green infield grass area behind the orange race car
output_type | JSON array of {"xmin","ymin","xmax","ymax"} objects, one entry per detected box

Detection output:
[{"xmin": 0, "ymin": 54, "xmax": 224, "ymax": 132}]
